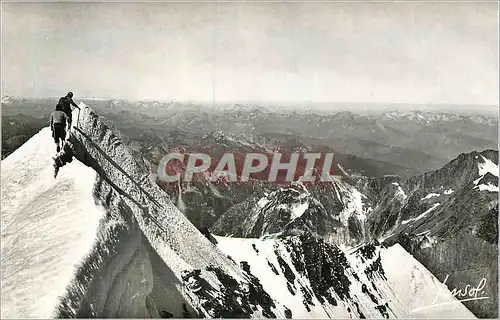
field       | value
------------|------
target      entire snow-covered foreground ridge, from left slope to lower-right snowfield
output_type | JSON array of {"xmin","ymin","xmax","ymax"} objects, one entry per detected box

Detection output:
[{"xmin": 1, "ymin": 104, "xmax": 480, "ymax": 318}]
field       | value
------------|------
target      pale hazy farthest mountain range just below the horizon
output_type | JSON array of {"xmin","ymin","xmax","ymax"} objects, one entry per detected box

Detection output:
[{"xmin": 2, "ymin": 98, "xmax": 498, "ymax": 175}]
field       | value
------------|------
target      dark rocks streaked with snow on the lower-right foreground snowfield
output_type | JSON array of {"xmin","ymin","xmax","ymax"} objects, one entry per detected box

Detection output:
[{"xmin": 211, "ymin": 234, "xmax": 394, "ymax": 318}]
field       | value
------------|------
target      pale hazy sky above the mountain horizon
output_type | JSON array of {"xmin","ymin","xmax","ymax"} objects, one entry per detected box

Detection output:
[{"xmin": 2, "ymin": 2, "xmax": 499, "ymax": 104}]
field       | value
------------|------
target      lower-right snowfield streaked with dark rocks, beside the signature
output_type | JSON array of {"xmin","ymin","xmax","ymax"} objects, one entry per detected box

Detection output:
[{"xmin": 216, "ymin": 235, "xmax": 475, "ymax": 318}]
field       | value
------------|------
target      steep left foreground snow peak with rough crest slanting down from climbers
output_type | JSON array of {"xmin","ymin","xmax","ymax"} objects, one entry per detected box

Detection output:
[{"xmin": 2, "ymin": 105, "xmax": 290, "ymax": 318}]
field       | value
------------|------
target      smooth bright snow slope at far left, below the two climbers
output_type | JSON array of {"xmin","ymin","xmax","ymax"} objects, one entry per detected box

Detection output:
[{"xmin": 1, "ymin": 128, "xmax": 105, "ymax": 319}]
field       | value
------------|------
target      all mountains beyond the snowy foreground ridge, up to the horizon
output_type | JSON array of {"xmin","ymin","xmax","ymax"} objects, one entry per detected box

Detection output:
[{"xmin": 2, "ymin": 98, "xmax": 498, "ymax": 317}]
